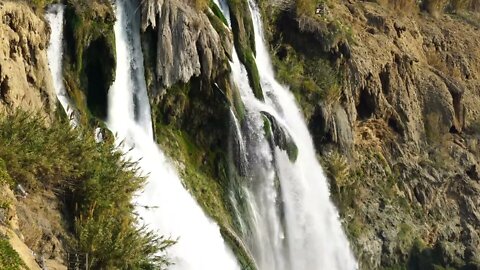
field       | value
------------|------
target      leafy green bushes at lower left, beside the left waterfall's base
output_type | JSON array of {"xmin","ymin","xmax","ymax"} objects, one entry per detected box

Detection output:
[{"xmin": 0, "ymin": 112, "xmax": 173, "ymax": 269}]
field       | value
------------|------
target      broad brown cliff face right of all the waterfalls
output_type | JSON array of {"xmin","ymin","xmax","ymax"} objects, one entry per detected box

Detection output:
[{"xmin": 264, "ymin": 1, "xmax": 480, "ymax": 269}]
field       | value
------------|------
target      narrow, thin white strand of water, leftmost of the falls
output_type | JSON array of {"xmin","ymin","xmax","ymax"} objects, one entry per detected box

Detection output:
[{"xmin": 45, "ymin": 4, "xmax": 78, "ymax": 127}]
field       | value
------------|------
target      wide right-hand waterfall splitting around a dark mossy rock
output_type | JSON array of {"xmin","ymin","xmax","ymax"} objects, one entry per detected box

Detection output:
[{"xmin": 220, "ymin": 0, "xmax": 358, "ymax": 270}]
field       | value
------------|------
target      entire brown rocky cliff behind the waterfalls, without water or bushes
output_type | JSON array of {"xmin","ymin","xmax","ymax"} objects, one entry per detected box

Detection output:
[{"xmin": 0, "ymin": 0, "xmax": 480, "ymax": 269}]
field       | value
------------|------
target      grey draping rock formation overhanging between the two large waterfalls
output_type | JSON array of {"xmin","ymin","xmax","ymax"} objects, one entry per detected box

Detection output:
[{"xmin": 142, "ymin": 0, "xmax": 232, "ymax": 88}]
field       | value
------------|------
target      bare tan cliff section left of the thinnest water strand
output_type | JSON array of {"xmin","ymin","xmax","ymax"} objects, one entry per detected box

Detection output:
[{"xmin": 0, "ymin": 2, "xmax": 56, "ymax": 116}]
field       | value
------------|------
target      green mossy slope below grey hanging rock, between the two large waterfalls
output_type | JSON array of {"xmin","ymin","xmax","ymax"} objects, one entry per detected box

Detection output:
[{"xmin": 152, "ymin": 77, "xmax": 252, "ymax": 269}]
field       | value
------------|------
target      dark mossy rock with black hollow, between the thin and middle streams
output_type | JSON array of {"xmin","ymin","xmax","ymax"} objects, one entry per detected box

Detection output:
[{"xmin": 64, "ymin": 0, "xmax": 116, "ymax": 122}]
